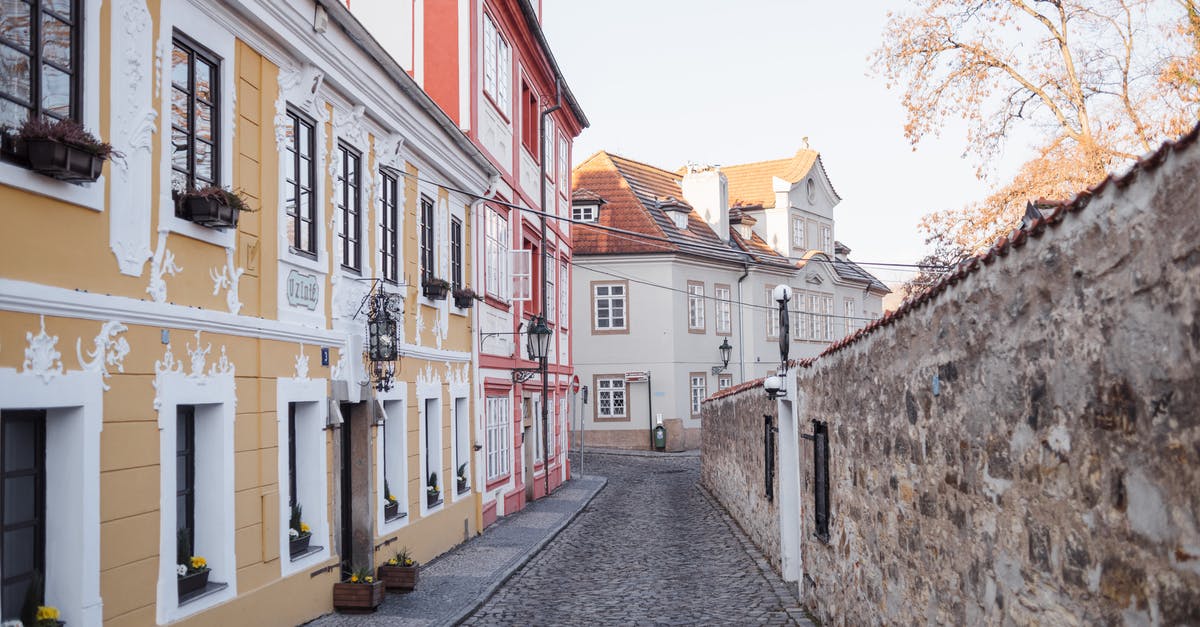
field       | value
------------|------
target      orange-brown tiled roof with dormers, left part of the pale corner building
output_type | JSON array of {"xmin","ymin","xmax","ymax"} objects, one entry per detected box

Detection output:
[{"xmin": 571, "ymin": 150, "xmax": 788, "ymax": 267}]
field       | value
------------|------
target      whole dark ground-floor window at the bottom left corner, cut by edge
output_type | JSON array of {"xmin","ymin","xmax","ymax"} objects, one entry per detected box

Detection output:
[{"xmin": 0, "ymin": 411, "xmax": 46, "ymax": 621}]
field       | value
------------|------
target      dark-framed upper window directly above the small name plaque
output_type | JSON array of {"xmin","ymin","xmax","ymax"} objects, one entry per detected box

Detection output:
[{"xmin": 282, "ymin": 107, "xmax": 317, "ymax": 258}]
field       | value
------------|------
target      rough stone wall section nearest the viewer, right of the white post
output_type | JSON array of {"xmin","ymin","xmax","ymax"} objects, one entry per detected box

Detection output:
[{"xmin": 796, "ymin": 133, "xmax": 1200, "ymax": 625}]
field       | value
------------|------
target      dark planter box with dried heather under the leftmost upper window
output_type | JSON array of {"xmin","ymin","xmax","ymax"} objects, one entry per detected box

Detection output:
[{"xmin": 6, "ymin": 118, "xmax": 120, "ymax": 183}]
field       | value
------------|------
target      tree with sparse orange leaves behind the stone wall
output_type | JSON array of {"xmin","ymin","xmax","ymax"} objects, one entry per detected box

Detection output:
[{"xmin": 872, "ymin": 0, "xmax": 1200, "ymax": 277}]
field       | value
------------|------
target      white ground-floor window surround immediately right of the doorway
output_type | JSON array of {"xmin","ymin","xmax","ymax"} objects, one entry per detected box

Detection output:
[{"xmin": 376, "ymin": 381, "xmax": 410, "ymax": 536}]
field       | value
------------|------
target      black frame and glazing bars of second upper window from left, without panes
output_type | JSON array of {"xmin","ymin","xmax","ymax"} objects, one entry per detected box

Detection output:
[{"xmin": 164, "ymin": 29, "xmax": 223, "ymax": 198}]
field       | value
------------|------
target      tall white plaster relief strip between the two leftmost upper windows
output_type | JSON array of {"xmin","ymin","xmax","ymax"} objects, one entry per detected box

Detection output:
[{"xmin": 108, "ymin": 0, "xmax": 154, "ymax": 276}]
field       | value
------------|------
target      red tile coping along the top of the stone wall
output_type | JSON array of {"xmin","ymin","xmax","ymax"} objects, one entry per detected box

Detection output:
[{"xmin": 704, "ymin": 124, "xmax": 1200, "ymax": 402}]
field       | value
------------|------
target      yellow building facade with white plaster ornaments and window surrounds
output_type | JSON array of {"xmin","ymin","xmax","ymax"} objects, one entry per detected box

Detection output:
[{"xmin": 0, "ymin": 0, "xmax": 496, "ymax": 626}]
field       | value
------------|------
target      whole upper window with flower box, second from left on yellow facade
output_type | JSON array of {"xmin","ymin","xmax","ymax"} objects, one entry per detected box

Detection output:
[{"xmin": 170, "ymin": 32, "xmax": 221, "ymax": 192}]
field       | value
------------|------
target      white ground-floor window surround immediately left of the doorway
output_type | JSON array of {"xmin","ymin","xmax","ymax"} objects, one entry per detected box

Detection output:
[{"xmin": 273, "ymin": 378, "xmax": 331, "ymax": 577}]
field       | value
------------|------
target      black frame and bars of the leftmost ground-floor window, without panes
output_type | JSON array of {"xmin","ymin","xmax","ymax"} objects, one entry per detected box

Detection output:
[{"xmin": 0, "ymin": 410, "xmax": 46, "ymax": 620}]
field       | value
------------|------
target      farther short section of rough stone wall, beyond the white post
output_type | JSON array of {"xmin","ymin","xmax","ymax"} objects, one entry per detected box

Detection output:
[{"xmin": 700, "ymin": 386, "xmax": 780, "ymax": 571}]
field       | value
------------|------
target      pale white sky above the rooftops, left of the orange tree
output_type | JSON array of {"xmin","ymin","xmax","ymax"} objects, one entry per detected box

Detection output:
[{"xmin": 542, "ymin": 0, "xmax": 1024, "ymax": 281}]
